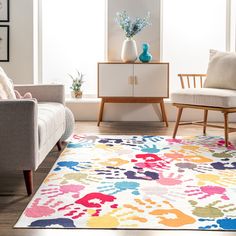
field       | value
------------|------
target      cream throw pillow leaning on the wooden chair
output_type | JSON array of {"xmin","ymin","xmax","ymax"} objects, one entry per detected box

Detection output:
[{"xmin": 204, "ymin": 50, "xmax": 236, "ymax": 90}]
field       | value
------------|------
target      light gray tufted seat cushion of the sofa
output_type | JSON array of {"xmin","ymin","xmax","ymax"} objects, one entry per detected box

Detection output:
[{"xmin": 38, "ymin": 102, "xmax": 65, "ymax": 149}]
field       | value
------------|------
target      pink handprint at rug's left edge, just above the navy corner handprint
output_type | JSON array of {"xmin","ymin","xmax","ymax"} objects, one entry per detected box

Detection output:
[{"xmin": 25, "ymin": 198, "xmax": 63, "ymax": 218}]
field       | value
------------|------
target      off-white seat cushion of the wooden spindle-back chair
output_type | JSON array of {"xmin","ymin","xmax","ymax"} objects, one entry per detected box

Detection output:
[{"xmin": 171, "ymin": 88, "xmax": 236, "ymax": 108}]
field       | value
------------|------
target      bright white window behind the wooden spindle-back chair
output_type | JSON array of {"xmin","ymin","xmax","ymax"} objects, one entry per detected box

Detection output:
[{"xmin": 162, "ymin": 0, "xmax": 227, "ymax": 90}]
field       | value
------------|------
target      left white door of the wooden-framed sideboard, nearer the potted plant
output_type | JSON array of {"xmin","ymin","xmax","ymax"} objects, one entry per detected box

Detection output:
[{"xmin": 98, "ymin": 64, "xmax": 133, "ymax": 97}]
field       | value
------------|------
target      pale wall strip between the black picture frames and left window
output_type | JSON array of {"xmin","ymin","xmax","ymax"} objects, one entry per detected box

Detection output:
[{"xmin": 0, "ymin": 0, "xmax": 38, "ymax": 84}]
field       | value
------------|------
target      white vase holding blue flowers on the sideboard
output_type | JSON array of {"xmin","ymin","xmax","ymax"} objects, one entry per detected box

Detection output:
[{"xmin": 121, "ymin": 38, "xmax": 138, "ymax": 62}]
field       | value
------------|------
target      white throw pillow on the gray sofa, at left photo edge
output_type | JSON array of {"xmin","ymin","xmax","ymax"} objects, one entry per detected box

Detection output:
[{"xmin": 0, "ymin": 67, "xmax": 16, "ymax": 99}]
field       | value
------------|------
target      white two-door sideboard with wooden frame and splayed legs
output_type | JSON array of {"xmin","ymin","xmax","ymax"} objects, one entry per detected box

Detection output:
[{"xmin": 98, "ymin": 62, "xmax": 169, "ymax": 126}]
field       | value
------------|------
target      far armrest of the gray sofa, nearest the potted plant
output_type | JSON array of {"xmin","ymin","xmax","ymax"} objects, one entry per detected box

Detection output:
[{"xmin": 14, "ymin": 84, "xmax": 65, "ymax": 104}]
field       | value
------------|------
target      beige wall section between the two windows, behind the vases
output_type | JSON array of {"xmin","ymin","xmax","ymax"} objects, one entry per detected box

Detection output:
[{"xmin": 107, "ymin": 0, "xmax": 161, "ymax": 61}]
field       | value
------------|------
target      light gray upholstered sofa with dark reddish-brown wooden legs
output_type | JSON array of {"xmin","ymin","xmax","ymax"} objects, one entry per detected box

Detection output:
[{"xmin": 0, "ymin": 85, "xmax": 65, "ymax": 195}]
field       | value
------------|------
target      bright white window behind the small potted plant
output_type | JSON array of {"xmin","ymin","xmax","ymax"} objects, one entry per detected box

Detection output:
[{"xmin": 42, "ymin": 0, "xmax": 105, "ymax": 94}]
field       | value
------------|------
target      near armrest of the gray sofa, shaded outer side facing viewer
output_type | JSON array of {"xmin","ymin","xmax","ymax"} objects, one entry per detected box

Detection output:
[{"xmin": 0, "ymin": 99, "xmax": 38, "ymax": 170}]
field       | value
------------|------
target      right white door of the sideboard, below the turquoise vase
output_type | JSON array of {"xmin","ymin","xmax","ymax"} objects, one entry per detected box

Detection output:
[{"xmin": 134, "ymin": 63, "xmax": 169, "ymax": 98}]
